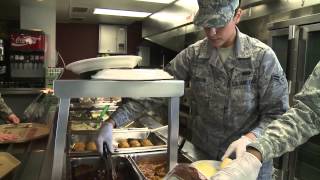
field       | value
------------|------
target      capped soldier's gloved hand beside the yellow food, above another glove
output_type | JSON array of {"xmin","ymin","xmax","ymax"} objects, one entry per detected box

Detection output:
[{"xmin": 222, "ymin": 136, "xmax": 252, "ymax": 160}]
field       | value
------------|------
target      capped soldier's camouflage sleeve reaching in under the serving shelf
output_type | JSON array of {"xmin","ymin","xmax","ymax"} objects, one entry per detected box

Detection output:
[{"xmin": 111, "ymin": 48, "xmax": 193, "ymax": 127}]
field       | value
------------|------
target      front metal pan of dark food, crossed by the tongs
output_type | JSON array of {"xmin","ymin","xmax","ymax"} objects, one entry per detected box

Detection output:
[{"xmin": 69, "ymin": 156, "xmax": 142, "ymax": 180}]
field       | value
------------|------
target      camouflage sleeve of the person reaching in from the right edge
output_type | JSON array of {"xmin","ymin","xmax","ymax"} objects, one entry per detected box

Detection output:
[{"xmin": 249, "ymin": 62, "xmax": 320, "ymax": 161}]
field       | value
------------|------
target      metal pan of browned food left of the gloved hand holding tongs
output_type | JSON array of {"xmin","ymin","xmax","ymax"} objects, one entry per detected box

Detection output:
[{"xmin": 68, "ymin": 133, "xmax": 98, "ymax": 156}]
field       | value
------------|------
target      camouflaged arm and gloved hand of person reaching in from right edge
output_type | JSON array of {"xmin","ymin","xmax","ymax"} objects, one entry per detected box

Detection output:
[{"xmin": 211, "ymin": 62, "xmax": 320, "ymax": 180}]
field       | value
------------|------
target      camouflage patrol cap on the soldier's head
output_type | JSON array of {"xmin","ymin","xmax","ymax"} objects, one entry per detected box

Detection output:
[{"xmin": 193, "ymin": 0, "xmax": 239, "ymax": 28}]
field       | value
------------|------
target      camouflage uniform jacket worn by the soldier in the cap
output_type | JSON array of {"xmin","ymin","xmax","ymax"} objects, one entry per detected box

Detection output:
[{"xmin": 111, "ymin": 30, "xmax": 288, "ymax": 176}]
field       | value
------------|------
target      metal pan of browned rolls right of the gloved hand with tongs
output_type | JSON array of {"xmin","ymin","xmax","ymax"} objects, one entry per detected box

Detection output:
[{"xmin": 113, "ymin": 130, "xmax": 167, "ymax": 154}]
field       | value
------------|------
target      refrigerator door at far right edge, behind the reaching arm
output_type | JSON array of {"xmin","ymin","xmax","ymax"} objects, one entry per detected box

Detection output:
[{"xmin": 293, "ymin": 23, "xmax": 320, "ymax": 180}]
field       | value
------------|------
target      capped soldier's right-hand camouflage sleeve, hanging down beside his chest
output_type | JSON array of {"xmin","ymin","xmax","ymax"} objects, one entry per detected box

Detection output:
[{"xmin": 251, "ymin": 49, "xmax": 289, "ymax": 137}]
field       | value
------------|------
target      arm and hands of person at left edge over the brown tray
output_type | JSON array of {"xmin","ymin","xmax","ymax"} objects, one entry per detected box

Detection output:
[{"xmin": 0, "ymin": 95, "xmax": 20, "ymax": 142}]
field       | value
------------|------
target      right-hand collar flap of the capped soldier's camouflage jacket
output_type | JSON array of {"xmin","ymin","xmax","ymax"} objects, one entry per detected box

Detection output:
[{"xmin": 235, "ymin": 27, "xmax": 252, "ymax": 58}]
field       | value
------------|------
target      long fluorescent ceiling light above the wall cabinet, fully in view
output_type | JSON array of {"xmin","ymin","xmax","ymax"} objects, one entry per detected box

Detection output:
[{"xmin": 93, "ymin": 8, "xmax": 151, "ymax": 17}]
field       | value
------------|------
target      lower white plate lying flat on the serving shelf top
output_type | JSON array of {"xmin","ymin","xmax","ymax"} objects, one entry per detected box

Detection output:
[{"xmin": 91, "ymin": 69, "xmax": 173, "ymax": 81}]
